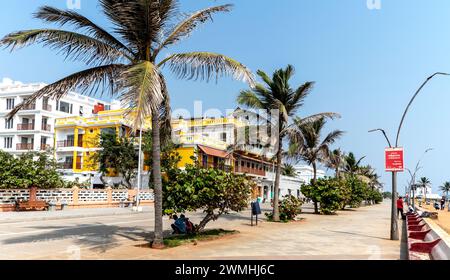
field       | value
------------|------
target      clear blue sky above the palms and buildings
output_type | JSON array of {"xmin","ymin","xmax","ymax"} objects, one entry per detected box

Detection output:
[{"xmin": 0, "ymin": 0, "xmax": 450, "ymax": 195}]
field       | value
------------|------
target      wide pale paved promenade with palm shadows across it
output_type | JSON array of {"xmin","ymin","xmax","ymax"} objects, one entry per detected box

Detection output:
[{"xmin": 0, "ymin": 203, "xmax": 400, "ymax": 260}]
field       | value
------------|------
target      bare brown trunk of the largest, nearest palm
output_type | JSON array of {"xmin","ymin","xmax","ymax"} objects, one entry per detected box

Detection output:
[{"xmin": 152, "ymin": 112, "xmax": 164, "ymax": 248}]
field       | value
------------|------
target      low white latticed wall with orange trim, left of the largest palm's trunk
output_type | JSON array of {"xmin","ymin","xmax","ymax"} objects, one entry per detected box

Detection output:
[{"xmin": 0, "ymin": 188, "xmax": 154, "ymax": 212}]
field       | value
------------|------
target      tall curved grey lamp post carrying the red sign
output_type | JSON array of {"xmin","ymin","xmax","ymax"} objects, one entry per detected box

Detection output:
[{"xmin": 369, "ymin": 72, "xmax": 450, "ymax": 240}]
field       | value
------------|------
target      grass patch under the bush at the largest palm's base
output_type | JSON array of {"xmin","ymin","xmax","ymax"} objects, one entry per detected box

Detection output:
[{"xmin": 164, "ymin": 229, "xmax": 239, "ymax": 248}]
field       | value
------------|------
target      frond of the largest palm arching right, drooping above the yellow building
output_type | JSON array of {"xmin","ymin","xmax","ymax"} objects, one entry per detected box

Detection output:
[{"xmin": 158, "ymin": 52, "xmax": 255, "ymax": 87}]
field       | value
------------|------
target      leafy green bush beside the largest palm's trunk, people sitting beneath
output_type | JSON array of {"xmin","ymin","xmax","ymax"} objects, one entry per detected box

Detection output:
[{"xmin": 163, "ymin": 165, "xmax": 255, "ymax": 232}]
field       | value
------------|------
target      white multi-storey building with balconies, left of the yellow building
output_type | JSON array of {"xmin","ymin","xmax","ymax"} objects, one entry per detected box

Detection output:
[{"xmin": 0, "ymin": 78, "xmax": 118, "ymax": 154}]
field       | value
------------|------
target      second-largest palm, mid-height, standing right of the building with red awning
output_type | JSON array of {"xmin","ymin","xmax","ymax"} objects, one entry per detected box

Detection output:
[{"xmin": 237, "ymin": 65, "xmax": 337, "ymax": 222}]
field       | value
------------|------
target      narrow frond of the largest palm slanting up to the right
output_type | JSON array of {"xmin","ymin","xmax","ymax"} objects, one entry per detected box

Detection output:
[{"xmin": 153, "ymin": 4, "xmax": 233, "ymax": 58}]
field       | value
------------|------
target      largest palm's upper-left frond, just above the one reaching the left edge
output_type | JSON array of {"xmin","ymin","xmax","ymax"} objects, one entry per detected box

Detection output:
[{"xmin": 35, "ymin": 6, "xmax": 133, "ymax": 60}]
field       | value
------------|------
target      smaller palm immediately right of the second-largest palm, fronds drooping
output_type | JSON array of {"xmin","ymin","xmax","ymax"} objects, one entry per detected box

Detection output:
[{"xmin": 288, "ymin": 118, "xmax": 344, "ymax": 214}]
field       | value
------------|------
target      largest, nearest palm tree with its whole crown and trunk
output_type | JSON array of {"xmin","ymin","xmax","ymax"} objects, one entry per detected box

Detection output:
[{"xmin": 0, "ymin": 0, "xmax": 253, "ymax": 247}]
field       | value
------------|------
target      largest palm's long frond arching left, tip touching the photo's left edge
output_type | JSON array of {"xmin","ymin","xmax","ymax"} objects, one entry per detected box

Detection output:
[{"xmin": 0, "ymin": 29, "xmax": 126, "ymax": 65}]
